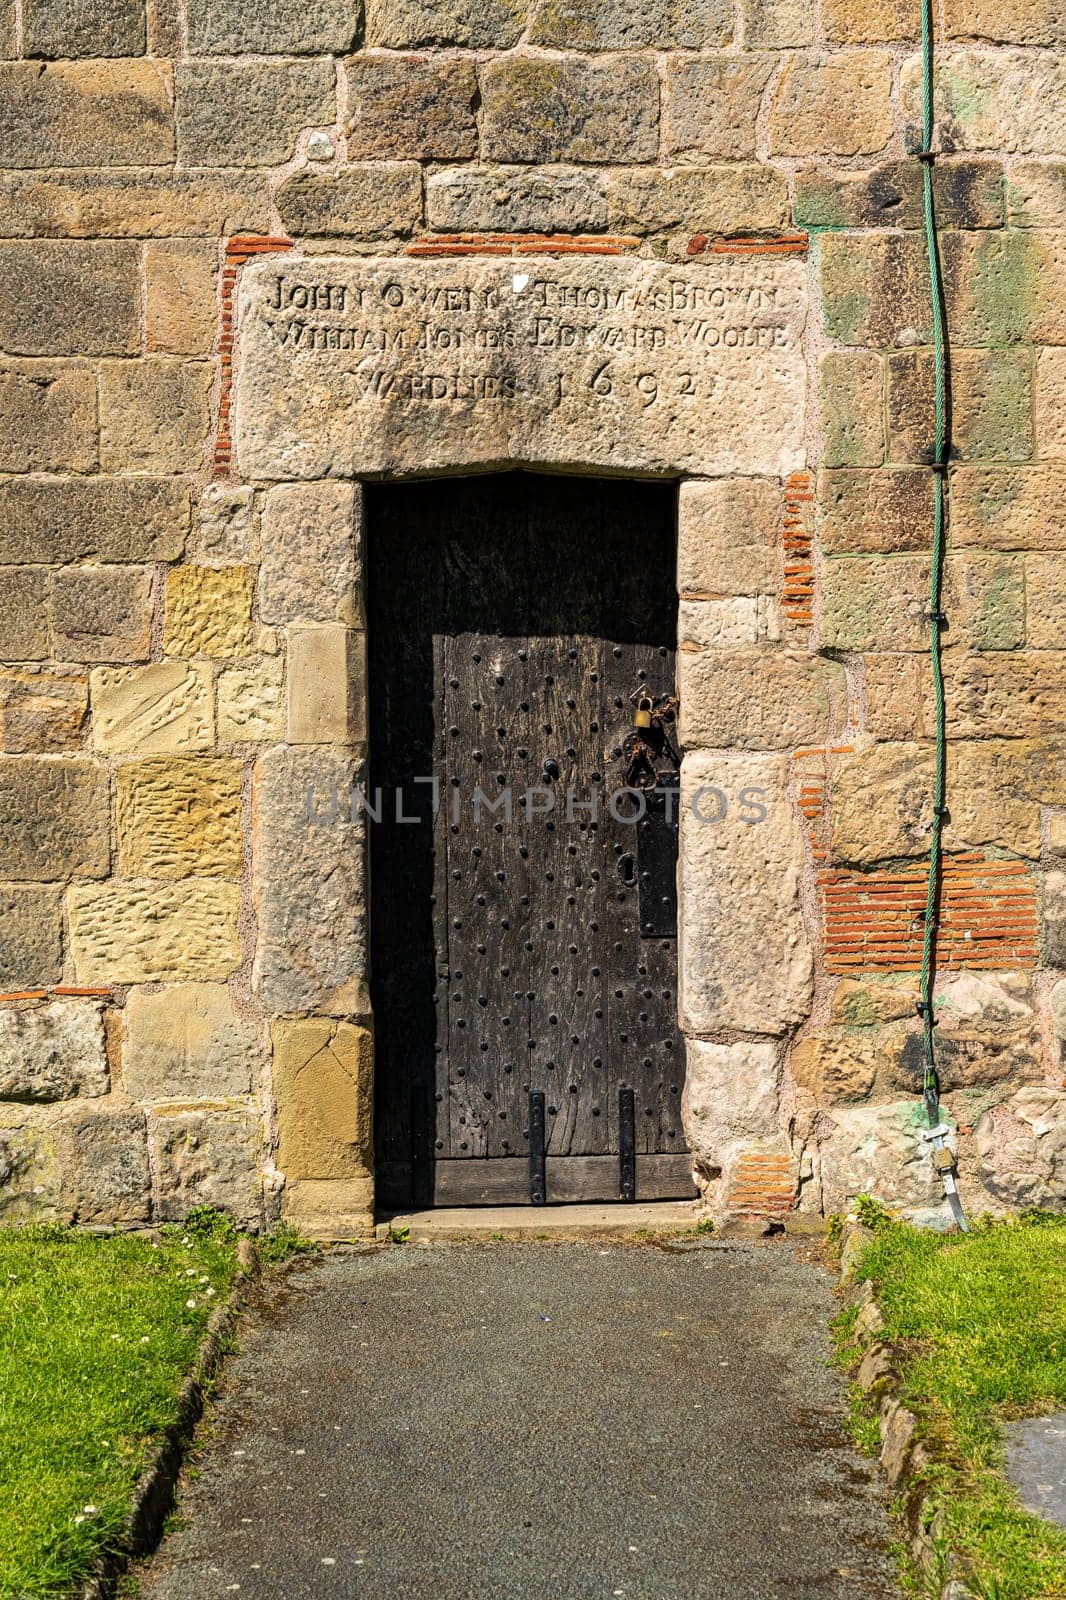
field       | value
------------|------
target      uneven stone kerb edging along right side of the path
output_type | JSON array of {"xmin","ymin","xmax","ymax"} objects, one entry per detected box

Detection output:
[{"xmin": 840, "ymin": 1222, "xmax": 976, "ymax": 1600}]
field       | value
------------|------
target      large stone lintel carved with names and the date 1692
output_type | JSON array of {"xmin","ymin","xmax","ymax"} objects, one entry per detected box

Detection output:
[{"xmin": 237, "ymin": 256, "xmax": 807, "ymax": 478}]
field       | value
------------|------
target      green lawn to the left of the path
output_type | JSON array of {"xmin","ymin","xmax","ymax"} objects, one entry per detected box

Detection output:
[{"xmin": 0, "ymin": 1224, "xmax": 237, "ymax": 1600}]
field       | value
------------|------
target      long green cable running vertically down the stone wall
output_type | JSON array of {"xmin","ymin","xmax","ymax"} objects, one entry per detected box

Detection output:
[{"xmin": 917, "ymin": 0, "xmax": 965, "ymax": 1229}]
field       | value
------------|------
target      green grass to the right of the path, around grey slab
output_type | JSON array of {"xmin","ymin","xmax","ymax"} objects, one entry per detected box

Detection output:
[{"xmin": 837, "ymin": 1216, "xmax": 1066, "ymax": 1600}]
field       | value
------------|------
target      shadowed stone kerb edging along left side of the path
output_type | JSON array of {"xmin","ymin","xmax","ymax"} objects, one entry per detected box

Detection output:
[{"xmin": 82, "ymin": 1237, "xmax": 259, "ymax": 1600}]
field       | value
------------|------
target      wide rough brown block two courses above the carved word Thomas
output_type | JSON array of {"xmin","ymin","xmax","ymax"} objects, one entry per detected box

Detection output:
[{"xmin": 480, "ymin": 54, "xmax": 659, "ymax": 162}]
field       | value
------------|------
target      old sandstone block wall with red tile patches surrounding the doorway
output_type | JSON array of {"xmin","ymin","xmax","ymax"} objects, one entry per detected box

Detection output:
[{"xmin": 0, "ymin": 0, "xmax": 1066, "ymax": 1232}]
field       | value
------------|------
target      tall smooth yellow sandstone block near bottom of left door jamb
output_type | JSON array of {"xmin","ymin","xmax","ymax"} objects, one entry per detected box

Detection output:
[{"xmin": 274, "ymin": 1016, "xmax": 375, "ymax": 1182}]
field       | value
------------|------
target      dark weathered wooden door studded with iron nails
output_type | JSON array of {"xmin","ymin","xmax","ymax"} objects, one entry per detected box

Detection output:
[{"xmin": 367, "ymin": 474, "xmax": 693, "ymax": 1208}]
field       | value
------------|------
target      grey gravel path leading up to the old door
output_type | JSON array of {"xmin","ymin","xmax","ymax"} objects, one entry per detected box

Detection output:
[{"xmin": 141, "ymin": 1238, "xmax": 898, "ymax": 1600}]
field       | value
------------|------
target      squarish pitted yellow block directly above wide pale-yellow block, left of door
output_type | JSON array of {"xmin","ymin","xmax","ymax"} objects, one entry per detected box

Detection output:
[{"xmin": 115, "ymin": 755, "xmax": 243, "ymax": 878}]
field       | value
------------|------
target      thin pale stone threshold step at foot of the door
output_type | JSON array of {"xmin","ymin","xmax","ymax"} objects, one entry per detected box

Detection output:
[{"xmin": 375, "ymin": 1200, "xmax": 704, "ymax": 1243}]
